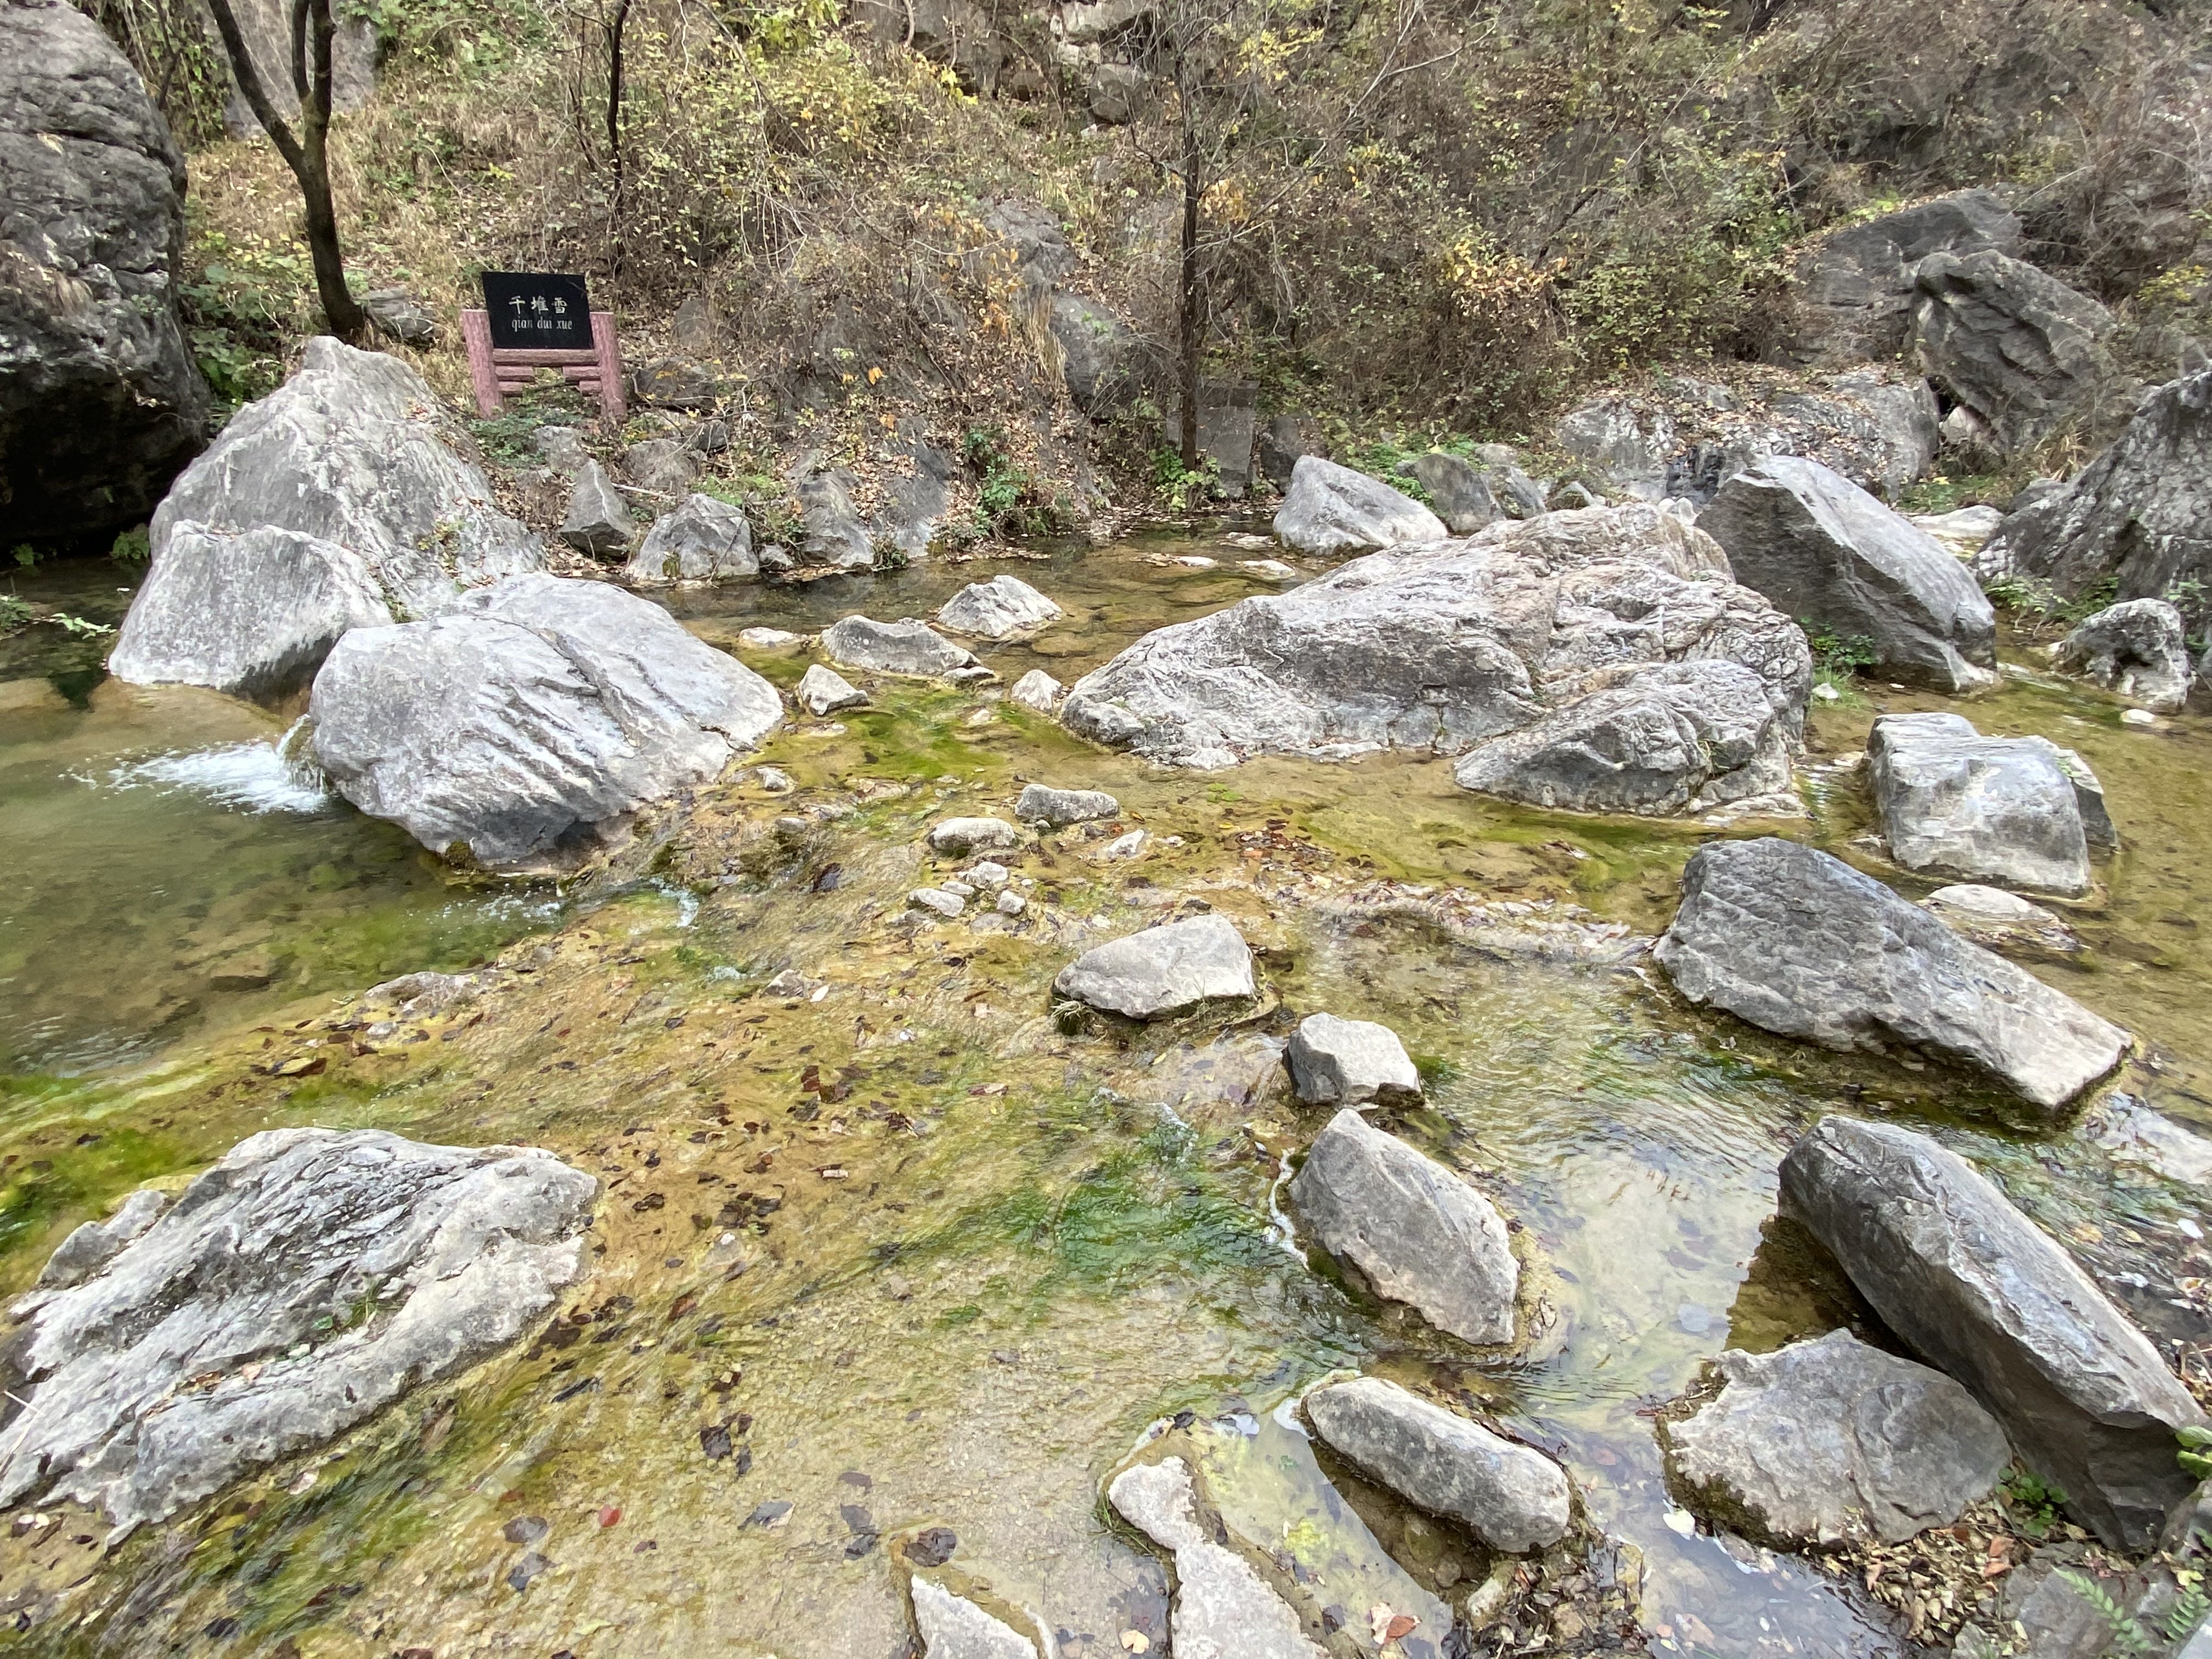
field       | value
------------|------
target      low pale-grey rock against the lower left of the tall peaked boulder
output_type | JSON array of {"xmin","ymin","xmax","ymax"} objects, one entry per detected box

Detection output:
[{"xmin": 109, "ymin": 522, "xmax": 392, "ymax": 699}]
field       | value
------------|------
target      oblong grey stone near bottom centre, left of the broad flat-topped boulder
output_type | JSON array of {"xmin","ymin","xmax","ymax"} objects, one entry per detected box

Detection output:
[{"xmin": 1305, "ymin": 1376, "xmax": 1575, "ymax": 1555}]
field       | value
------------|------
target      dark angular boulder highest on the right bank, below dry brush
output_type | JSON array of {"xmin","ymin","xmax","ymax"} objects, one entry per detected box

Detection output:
[{"xmin": 1907, "ymin": 250, "xmax": 2115, "ymax": 458}]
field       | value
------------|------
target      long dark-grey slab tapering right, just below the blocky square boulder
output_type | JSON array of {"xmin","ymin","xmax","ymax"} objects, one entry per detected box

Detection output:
[{"xmin": 1652, "ymin": 836, "xmax": 2128, "ymax": 1117}]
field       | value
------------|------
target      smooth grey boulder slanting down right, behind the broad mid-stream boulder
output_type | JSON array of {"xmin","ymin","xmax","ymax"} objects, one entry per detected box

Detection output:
[{"xmin": 1697, "ymin": 456, "xmax": 1997, "ymax": 692}]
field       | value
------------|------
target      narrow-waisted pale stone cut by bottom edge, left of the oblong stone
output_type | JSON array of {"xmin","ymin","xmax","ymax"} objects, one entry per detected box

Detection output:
[{"xmin": 1106, "ymin": 1458, "xmax": 1327, "ymax": 1659}]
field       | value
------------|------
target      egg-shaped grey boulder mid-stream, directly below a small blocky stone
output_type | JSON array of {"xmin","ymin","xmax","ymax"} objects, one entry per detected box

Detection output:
[{"xmin": 1290, "ymin": 1108, "xmax": 1520, "ymax": 1347}]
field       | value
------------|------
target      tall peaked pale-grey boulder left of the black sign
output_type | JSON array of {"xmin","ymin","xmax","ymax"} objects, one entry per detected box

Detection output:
[{"xmin": 153, "ymin": 338, "xmax": 544, "ymax": 617}]
